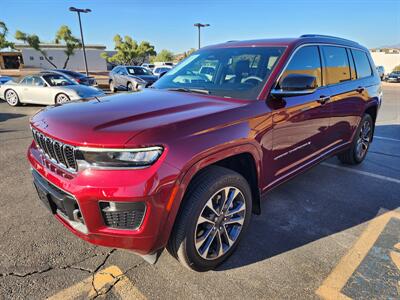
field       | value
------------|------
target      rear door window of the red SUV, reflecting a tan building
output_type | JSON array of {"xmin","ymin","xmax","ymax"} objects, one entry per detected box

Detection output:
[{"xmin": 321, "ymin": 46, "xmax": 351, "ymax": 84}]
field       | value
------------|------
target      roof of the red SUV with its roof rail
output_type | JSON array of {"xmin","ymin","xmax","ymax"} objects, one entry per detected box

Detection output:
[{"xmin": 203, "ymin": 34, "xmax": 366, "ymax": 50}]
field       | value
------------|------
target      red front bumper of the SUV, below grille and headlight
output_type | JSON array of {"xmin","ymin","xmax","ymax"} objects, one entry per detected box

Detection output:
[{"xmin": 28, "ymin": 143, "xmax": 178, "ymax": 255}]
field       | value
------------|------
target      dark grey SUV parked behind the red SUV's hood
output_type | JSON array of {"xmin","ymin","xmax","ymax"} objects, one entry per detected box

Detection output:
[{"xmin": 109, "ymin": 66, "xmax": 158, "ymax": 92}]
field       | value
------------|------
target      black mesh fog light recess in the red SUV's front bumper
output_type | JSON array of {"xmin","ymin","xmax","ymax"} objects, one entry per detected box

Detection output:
[{"xmin": 99, "ymin": 201, "xmax": 146, "ymax": 230}]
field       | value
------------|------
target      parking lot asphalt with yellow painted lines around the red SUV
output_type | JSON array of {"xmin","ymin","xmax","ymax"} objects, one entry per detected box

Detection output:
[{"xmin": 0, "ymin": 84, "xmax": 400, "ymax": 299}]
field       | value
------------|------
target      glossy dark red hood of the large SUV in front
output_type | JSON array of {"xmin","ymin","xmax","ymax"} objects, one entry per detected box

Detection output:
[{"xmin": 31, "ymin": 89, "xmax": 244, "ymax": 147}]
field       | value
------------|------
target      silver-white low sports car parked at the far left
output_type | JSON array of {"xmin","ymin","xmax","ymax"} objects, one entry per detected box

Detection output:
[{"xmin": 0, "ymin": 73, "xmax": 104, "ymax": 106}]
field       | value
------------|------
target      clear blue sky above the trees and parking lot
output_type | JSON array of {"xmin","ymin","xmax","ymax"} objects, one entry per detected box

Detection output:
[{"xmin": 0, "ymin": 0, "xmax": 400, "ymax": 52}]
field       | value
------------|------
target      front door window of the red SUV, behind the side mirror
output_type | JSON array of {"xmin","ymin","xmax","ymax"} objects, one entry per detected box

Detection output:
[{"xmin": 279, "ymin": 46, "xmax": 322, "ymax": 87}]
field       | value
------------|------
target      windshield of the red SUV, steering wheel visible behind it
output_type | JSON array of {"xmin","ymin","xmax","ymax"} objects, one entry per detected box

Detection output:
[{"xmin": 153, "ymin": 47, "xmax": 285, "ymax": 99}]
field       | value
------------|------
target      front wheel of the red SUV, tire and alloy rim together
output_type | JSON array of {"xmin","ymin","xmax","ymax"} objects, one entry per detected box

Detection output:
[{"xmin": 168, "ymin": 166, "xmax": 252, "ymax": 271}]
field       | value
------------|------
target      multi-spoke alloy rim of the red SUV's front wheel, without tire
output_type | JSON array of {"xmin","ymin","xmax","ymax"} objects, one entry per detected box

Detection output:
[{"xmin": 194, "ymin": 186, "xmax": 246, "ymax": 260}]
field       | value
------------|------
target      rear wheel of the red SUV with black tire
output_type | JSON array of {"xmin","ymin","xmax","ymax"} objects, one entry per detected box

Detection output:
[{"xmin": 337, "ymin": 114, "xmax": 375, "ymax": 165}]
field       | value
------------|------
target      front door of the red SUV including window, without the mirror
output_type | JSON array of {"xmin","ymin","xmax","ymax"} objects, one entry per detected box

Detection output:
[{"xmin": 270, "ymin": 45, "xmax": 331, "ymax": 184}]
